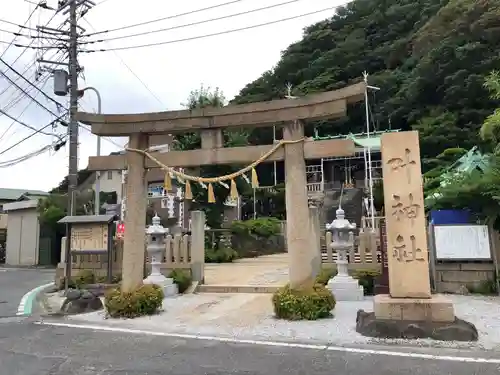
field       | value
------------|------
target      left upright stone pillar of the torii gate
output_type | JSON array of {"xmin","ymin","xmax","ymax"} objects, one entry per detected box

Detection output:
[{"xmin": 122, "ymin": 134, "xmax": 148, "ymax": 292}]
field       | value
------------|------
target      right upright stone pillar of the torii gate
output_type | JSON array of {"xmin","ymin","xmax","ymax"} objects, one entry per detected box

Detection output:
[{"xmin": 283, "ymin": 121, "xmax": 317, "ymax": 288}]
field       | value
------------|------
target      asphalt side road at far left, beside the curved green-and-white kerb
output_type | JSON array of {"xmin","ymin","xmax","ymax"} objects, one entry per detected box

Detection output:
[{"xmin": 0, "ymin": 268, "xmax": 54, "ymax": 317}]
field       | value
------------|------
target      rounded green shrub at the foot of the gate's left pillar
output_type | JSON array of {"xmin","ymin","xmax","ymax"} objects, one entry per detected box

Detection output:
[{"xmin": 104, "ymin": 284, "xmax": 164, "ymax": 318}]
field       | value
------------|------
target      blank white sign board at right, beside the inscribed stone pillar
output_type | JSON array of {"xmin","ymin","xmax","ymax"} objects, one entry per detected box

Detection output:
[{"xmin": 434, "ymin": 225, "xmax": 491, "ymax": 260}]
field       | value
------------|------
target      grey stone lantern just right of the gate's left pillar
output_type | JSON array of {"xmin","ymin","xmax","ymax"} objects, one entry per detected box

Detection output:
[{"xmin": 144, "ymin": 215, "xmax": 178, "ymax": 297}]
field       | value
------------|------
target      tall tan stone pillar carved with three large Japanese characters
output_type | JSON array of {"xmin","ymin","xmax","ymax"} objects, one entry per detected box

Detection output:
[{"xmin": 381, "ymin": 131, "xmax": 431, "ymax": 298}]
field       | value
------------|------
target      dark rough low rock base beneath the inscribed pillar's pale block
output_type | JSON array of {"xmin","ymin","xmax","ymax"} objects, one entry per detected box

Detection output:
[{"xmin": 356, "ymin": 310, "xmax": 478, "ymax": 341}]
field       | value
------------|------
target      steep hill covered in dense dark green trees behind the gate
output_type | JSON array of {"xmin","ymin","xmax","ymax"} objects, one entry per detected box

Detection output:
[{"xmin": 233, "ymin": 0, "xmax": 500, "ymax": 164}]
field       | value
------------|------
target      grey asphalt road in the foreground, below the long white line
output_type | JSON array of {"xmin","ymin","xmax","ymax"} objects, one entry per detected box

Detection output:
[{"xmin": 0, "ymin": 319, "xmax": 499, "ymax": 375}]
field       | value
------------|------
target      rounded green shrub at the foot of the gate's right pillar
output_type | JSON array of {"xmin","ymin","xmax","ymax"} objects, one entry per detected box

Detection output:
[{"xmin": 272, "ymin": 284, "xmax": 335, "ymax": 320}]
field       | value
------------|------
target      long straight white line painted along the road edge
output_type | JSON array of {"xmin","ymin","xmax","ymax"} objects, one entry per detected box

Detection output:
[{"xmin": 35, "ymin": 321, "xmax": 500, "ymax": 364}]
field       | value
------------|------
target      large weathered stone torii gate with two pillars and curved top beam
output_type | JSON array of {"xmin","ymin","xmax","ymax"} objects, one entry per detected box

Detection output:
[{"xmin": 77, "ymin": 83, "xmax": 365, "ymax": 291}]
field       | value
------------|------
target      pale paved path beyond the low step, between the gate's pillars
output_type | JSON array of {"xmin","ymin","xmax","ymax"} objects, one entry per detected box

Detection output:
[{"xmin": 205, "ymin": 253, "xmax": 288, "ymax": 286}]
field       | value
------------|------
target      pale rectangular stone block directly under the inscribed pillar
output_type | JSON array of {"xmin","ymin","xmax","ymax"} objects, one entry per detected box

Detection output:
[{"xmin": 373, "ymin": 294, "xmax": 455, "ymax": 322}]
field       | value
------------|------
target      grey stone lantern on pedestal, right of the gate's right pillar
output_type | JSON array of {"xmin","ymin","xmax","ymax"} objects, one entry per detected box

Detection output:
[{"xmin": 326, "ymin": 207, "xmax": 364, "ymax": 301}]
